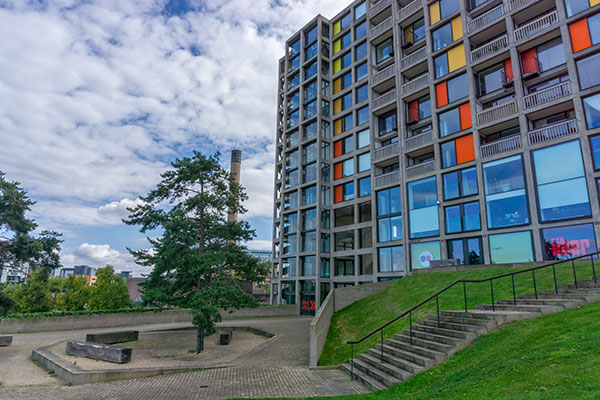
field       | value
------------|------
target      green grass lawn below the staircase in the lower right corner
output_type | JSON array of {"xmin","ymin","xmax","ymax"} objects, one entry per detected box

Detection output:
[{"xmin": 230, "ymin": 302, "xmax": 600, "ymax": 400}]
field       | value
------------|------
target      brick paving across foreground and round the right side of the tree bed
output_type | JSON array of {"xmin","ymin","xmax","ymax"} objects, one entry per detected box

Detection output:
[{"xmin": 0, "ymin": 318, "xmax": 368, "ymax": 400}]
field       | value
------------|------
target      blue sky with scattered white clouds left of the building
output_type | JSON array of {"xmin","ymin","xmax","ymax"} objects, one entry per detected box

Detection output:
[{"xmin": 0, "ymin": 0, "xmax": 343, "ymax": 276}]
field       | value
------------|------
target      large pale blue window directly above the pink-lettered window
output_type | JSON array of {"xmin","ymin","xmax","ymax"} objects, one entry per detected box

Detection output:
[{"xmin": 532, "ymin": 140, "xmax": 591, "ymax": 222}]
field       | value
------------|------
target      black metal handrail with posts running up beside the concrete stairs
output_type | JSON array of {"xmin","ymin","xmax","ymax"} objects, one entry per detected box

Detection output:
[{"xmin": 346, "ymin": 251, "xmax": 600, "ymax": 379}]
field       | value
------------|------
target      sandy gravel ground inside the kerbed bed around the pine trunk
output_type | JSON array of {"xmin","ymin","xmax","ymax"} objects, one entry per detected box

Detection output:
[{"xmin": 50, "ymin": 329, "xmax": 269, "ymax": 370}]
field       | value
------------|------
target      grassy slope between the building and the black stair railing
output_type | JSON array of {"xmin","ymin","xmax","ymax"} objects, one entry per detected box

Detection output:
[{"xmin": 319, "ymin": 265, "xmax": 592, "ymax": 365}]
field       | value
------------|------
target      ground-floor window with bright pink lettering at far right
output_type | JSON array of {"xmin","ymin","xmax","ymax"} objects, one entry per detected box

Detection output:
[{"xmin": 542, "ymin": 224, "xmax": 597, "ymax": 260}]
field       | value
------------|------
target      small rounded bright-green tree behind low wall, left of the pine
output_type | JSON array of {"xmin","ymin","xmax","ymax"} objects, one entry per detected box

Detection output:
[{"xmin": 86, "ymin": 265, "xmax": 131, "ymax": 310}]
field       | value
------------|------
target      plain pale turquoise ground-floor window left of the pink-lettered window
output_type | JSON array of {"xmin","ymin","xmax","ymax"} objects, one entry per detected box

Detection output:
[{"xmin": 490, "ymin": 231, "xmax": 535, "ymax": 264}]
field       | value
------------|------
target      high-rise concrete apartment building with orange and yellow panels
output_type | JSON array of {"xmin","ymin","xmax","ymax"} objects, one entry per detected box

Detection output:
[{"xmin": 271, "ymin": 0, "xmax": 600, "ymax": 314}]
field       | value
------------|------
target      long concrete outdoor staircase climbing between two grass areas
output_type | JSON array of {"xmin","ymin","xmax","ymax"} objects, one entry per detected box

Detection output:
[{"xmin": 340, "ymin": 277, "xmax": 600, "ymax": 390}]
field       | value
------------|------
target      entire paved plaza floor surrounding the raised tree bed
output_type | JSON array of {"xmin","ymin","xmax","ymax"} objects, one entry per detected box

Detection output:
[{"xmin": 0, "ymin": 318, "xmax": 367, "ymax": 400}]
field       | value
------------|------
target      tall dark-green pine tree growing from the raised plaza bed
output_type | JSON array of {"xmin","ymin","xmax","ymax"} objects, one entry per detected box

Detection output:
[{"xmin": 124, "ymin": 151, "xmax": 267, "ymax": 351}]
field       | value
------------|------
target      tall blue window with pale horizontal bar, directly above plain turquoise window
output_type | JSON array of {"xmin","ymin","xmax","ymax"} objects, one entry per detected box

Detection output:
[{"xmin": 483, "ymin": 154, "xmax": 529, "ymax": 228}]
